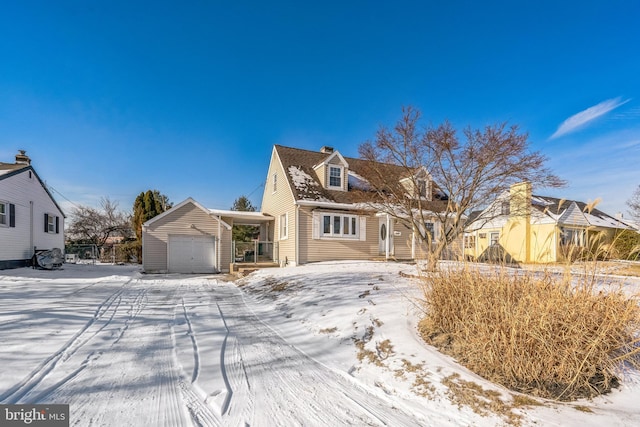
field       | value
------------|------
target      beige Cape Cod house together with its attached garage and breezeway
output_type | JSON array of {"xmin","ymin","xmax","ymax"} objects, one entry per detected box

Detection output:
[{"xmin": 142, "ymin": 145, "xmax": 450, "ymax": 273}]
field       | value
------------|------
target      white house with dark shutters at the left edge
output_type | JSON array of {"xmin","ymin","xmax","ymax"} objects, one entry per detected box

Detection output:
[{"xmin": 0, "ymin": 150, "xmax": 65, "ymax": 269}]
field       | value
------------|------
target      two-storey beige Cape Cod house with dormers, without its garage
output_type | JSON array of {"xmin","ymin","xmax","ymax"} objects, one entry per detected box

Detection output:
[{"xmin": 261, "ymin": 145, "xmax": 448, "ymax": 266}]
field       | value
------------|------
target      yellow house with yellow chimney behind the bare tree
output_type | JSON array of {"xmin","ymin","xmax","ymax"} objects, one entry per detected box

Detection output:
[{"xmin": 464, "ymin": 182, "xmax": 630, "ymax": 263}]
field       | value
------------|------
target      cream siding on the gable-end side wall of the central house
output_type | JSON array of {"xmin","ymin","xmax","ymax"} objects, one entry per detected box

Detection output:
[{"xmin": 261, "ymin": 149, "xmax": 304, "ymax": 265}]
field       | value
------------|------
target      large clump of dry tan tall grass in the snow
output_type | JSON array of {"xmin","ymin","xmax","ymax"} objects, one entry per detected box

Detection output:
[{"xmin": 420, "ymin": 265, "xmax": 640, "ymax": 400}]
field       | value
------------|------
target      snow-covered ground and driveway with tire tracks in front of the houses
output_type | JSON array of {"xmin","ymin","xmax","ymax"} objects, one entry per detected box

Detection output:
[{"xmin": 0, "ymin": 262, "xmax": 640, "ymax": 426}]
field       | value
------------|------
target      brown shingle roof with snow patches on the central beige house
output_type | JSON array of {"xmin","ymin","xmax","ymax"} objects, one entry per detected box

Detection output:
[{"xmin": 274, "ymin": 145, "xmax": 446, "ymax": 212}]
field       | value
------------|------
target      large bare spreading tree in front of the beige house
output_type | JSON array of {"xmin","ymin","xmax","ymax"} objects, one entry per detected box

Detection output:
[{"xmin": 359, "ymin": 107, "xmax": 564, "ymax": 269}]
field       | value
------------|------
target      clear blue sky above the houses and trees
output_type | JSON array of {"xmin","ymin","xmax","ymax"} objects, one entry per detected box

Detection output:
[{"xmin": 0, "ymin": 0, "xmax": 640, "ymax": 219}]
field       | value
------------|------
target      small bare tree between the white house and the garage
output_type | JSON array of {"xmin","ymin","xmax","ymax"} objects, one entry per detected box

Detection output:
[{"xmin": 67, "ymin": 197, "xmax": 133, "ymax": 246}]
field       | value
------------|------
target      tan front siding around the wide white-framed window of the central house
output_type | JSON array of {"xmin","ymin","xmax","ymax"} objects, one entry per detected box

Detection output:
[{"xmin": 299, "ymin": 208, "xmax": 378, "ymax": 263}]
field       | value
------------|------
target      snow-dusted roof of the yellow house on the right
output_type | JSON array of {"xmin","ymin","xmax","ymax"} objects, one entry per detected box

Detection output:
[{"xmin": 531, "ymin": 195, "xmax": 631, "ymax": 228}]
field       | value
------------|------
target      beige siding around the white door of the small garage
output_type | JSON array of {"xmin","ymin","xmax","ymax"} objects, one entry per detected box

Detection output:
[{"xmin": 142, "ymin": 203, "xmax": 231, "ymax": 273}]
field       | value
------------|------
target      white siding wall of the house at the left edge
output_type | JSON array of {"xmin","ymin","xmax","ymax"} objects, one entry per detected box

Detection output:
[{"xmin": 0, "ymin": 170, "xmax": 64, "ymax": 261}]
